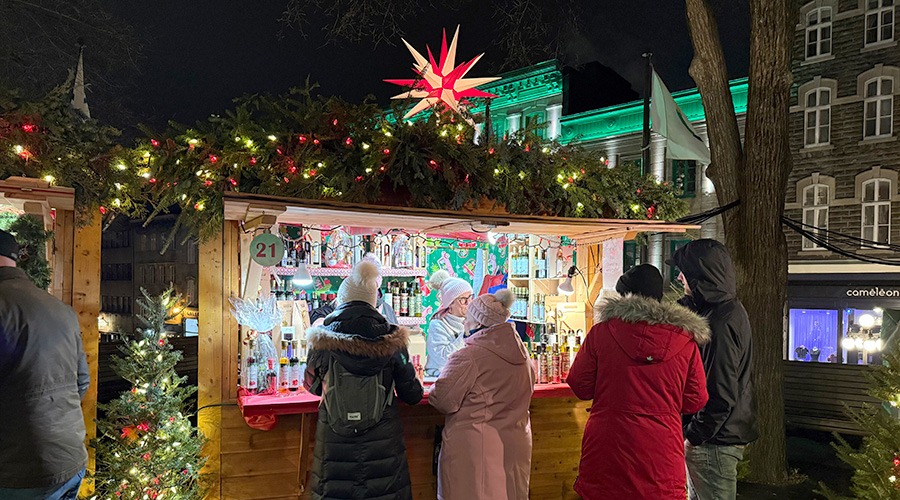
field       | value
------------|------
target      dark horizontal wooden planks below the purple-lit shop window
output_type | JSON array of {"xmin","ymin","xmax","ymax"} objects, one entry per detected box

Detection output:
[{"xmin": 784, "ymin": 361, "xmax": 880, "ymax": 434}]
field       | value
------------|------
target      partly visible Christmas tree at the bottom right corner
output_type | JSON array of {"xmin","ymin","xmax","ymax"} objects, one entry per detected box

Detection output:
[{"xmin": 819, "ymin": 329, "xmax": 900, "ymax": 500}]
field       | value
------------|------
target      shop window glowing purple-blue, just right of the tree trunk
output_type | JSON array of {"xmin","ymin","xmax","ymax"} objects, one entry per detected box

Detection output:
[{"xmin": 788, "ymin": 309, "xmax": 838, "ymax": 363}]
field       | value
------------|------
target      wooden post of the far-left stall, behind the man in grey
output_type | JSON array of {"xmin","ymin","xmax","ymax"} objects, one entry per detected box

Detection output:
[{"xmin": 71, "ymin": 213, "xmax": 102, "ymax": 496}]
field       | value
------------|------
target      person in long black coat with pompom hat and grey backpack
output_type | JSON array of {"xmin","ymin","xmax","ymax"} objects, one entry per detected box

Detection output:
[{"xmin": 304, "ymin": 261, "xmax": 423, "ymax": 500}]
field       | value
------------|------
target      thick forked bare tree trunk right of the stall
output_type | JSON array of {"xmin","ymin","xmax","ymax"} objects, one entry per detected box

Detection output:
[{"xmin": 685, "ymin": 0, "xmax": 791, "ymax": 483}]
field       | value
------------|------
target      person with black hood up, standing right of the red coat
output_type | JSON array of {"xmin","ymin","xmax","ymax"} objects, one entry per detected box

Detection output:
[{"xmin": 669, "ymin": 239, "xmax": 758, "ymax": 500}]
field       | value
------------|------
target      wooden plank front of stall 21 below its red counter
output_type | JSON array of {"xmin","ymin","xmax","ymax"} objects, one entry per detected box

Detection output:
[{"xmin": 214, "ymin": 398, "xmax": 590, "ymax": 500}]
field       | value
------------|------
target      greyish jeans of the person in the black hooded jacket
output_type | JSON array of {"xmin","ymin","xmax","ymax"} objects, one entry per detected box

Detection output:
[{"xmin": 684, "ymin": 442, "xmax": 744, "ymax": 500}]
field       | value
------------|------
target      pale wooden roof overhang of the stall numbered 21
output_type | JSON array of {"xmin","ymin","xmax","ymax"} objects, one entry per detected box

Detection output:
[{"xmin": 224, "ymin": 193, "xmax": 699, "ymax": 244}]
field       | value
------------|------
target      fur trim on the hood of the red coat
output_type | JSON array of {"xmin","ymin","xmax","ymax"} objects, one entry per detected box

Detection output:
[{"xmin": 594, "ymin": 295, "xmax": 712, "ymax": 345}]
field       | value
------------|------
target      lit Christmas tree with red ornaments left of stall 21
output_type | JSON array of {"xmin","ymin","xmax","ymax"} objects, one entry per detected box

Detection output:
[{"xmin": 93, "ymin": 289, "xmax": 206, "ymax": 500}]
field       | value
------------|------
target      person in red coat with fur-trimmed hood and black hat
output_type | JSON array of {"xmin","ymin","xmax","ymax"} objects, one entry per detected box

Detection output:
[{"xmin": 567, "ymin": 264, "xmax": 710, "ymax": 500}]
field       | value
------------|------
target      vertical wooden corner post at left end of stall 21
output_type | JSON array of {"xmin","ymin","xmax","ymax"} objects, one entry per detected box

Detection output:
[{"xmin": 197, "ymin": 228, "xmax": 227, "ymax": 499}]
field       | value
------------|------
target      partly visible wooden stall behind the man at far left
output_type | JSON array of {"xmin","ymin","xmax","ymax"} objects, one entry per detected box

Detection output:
[{"xmin": 0, "ymin": 177, "xmax": 101, "ymax": 494}]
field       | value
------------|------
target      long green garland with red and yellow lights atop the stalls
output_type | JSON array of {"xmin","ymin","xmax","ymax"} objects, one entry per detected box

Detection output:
[{"xmin": 0, "ymin": 83, "xmax": 687, "ymax": 245}]
